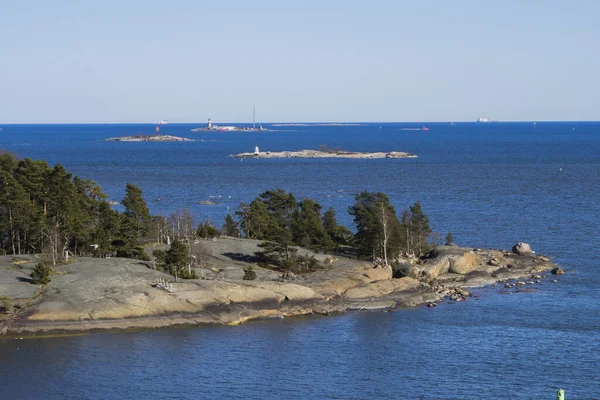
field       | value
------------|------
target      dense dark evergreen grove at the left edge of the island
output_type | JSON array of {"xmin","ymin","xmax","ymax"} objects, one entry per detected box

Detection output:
[{"xmin": 0, "ymin": 154, "xmax": 152, "ymax": 264}]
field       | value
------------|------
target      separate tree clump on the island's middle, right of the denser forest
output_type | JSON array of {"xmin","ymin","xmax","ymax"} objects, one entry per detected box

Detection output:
[{"xmin": 232, "ymin": 189, "xmax": 431, "ymax": 272}]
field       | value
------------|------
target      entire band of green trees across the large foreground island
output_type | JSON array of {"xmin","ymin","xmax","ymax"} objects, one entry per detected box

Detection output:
[{"xmin": 0, "ymin": 153, "xmax": 431, "ymax": 276}]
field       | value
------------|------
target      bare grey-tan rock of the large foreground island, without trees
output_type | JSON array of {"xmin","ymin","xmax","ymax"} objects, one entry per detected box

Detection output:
[{"xmin": 0, "ymin": 239, "xmax": 556, "ymax": 337}]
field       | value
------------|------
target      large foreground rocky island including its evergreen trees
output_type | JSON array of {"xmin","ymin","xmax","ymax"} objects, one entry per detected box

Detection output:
[{"xmin": 0, "ymin": 153, "xmax": 562, "ymax": 336}]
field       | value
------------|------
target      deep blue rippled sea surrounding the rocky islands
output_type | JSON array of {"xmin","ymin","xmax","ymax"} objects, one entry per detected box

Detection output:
[{"xmin": 0, "ymin": 122, "xmax": 600, "ymax": 400}]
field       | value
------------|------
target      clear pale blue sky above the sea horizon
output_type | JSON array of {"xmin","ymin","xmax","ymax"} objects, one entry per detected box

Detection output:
[{"xmin": 0, "ymin": 0, "xmax": 600, "ymax": 124}]
